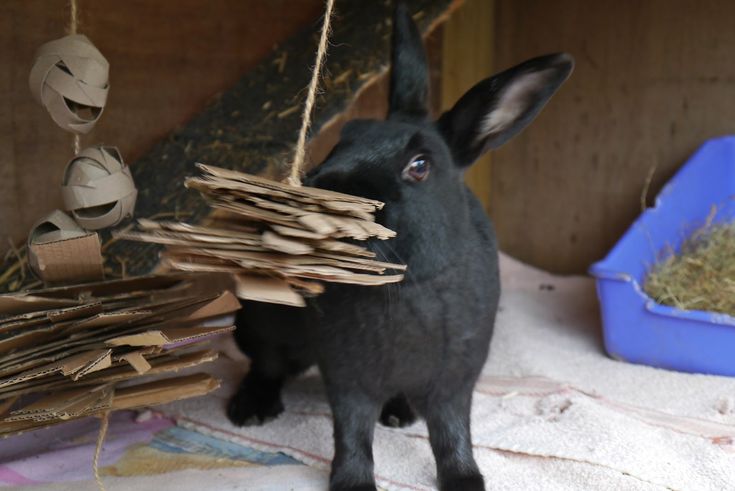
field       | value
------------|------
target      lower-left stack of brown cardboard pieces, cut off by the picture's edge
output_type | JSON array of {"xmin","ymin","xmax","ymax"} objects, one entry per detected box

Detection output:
[{"xmin": 0, "ymin": 273, "xmax": 240, "ymax": 436}]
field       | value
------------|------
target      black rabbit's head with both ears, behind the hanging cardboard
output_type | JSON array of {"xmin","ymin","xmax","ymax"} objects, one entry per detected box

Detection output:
[{"xmin": 306, "ymin": 5, "xmax": 574, "ymax": 278}]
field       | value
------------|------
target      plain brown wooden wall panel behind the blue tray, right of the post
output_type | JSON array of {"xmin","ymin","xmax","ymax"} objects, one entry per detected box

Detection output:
[{"xmin": 491, "ymin": 0, "xmax": 735, "ymax": 273}]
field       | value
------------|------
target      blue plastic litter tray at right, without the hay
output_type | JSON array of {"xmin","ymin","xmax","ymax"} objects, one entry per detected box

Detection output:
[{"xmin": 590, "ymin": 136, "xmax": 735, "ymax": 376}]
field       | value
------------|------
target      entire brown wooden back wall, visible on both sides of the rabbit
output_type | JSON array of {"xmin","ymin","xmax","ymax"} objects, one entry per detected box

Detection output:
[{"xmin": 0, "ymin": 0, "xmax": 735, "ymax": 273}]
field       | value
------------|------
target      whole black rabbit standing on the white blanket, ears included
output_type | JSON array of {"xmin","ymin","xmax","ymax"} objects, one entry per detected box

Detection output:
[{"xmin": 228, "ymin": 6, "xmax": 573, "ymax": 491}]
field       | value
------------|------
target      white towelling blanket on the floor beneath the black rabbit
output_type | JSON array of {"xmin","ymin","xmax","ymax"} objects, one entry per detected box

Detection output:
[{"xmin": 158, "ymin": 256, "xmax": 735, "ymax": 490}]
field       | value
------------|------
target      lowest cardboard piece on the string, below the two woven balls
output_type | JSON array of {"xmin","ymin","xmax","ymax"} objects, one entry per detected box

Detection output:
[{"xmin": 28, "ymin": 210, "xmax": 104, "ymax": 283}]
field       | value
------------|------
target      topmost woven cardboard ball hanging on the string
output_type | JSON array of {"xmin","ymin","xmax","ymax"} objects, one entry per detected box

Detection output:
[{"xmin": 28, "ymin": 34, "xmax": 110, "ymax": 133}]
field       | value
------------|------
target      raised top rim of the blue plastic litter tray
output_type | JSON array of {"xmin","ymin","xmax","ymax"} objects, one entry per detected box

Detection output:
[{"xmin": 588, "ymin": 136, "xmax": 735, "ymax": 327}]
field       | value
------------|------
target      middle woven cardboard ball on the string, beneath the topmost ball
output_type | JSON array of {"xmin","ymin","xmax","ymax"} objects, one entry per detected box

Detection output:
[{"xmin": 61, "ymin": 146, "xmax": 138, "ymax": 230}]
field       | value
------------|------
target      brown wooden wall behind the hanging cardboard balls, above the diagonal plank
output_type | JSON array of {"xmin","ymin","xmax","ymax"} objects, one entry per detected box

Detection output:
[{"xmin": 0, "ymin": 0, "xmax": 323, "ymax": 258}]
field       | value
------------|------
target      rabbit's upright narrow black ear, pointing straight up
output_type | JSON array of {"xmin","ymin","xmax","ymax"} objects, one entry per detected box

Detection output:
[{"xmin": 388, "ymin": 3, "xmax": 429, "ymax": 119}]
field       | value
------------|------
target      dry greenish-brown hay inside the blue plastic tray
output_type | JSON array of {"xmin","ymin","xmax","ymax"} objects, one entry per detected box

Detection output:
[{"xmin": 644, "ymin": 222, "xmax": 735, "ymax": 316}]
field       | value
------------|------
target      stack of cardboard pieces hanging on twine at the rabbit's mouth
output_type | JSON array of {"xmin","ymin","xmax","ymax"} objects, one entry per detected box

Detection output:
[{"xmin": 118, "ymin": 164, "xmax": 406, "ymax": 306}]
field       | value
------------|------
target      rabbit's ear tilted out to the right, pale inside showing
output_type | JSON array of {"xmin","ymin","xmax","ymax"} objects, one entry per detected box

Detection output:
[{"xmin": 438, "ymin": 53, "xmax": 574, "ymax": 167}]
